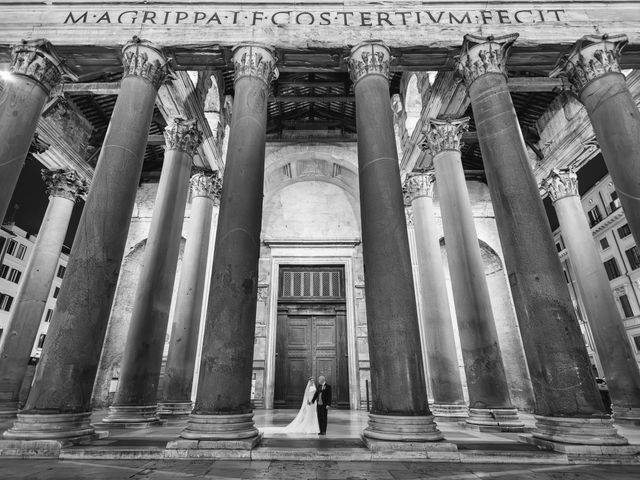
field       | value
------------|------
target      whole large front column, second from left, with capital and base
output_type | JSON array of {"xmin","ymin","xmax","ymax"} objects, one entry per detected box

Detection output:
[{"xmin": 4, "ymin": 38, "xmax": 167, "ymax": 441}]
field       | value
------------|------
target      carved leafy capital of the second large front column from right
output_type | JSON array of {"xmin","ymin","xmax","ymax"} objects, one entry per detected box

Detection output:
[{"xmin": 458, "ymin": 33, "xmax": 518, "ymax": 88}]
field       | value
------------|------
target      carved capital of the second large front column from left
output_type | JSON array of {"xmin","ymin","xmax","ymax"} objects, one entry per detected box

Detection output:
[{"xmin": 122, "ymin": 37, "xmax": 170, "ymax": 90}]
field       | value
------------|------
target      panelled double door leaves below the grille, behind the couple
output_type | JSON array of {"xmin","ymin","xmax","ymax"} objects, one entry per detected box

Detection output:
[{"xmin": 274, "ymin": 304, "xmax": 349, "ymax": 408}]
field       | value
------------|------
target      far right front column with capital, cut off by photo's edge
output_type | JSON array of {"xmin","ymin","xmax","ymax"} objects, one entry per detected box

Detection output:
[{"xmin": 551, "ymin": 35, "xmax": 640, "ymax": 245}]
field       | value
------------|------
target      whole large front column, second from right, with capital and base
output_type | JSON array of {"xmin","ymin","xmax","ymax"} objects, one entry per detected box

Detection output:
[{"xmin": 458, "ymin": 34, "xmax": 627, "ymax": 448}]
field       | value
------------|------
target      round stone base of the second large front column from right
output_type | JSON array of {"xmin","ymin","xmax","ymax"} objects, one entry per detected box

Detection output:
[{"xmin": 530, "ymin": 415, "xmax": 629, "ymax": 451}]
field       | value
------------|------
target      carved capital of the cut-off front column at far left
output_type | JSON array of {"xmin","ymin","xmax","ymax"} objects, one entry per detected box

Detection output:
[{"xmin": 10, "ymin": 40, "xmax": 77, "ymax": 95}]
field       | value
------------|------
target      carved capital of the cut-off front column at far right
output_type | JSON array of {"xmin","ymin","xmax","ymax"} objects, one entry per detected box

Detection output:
[{"xmin": 549, "ymin": 35, "xmax": 629, "ymax": 95}]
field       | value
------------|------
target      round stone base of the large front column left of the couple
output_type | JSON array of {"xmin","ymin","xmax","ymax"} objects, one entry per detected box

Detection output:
[{"xmin": 180, "ymin": 413, "xmax": 259, "ymax": 442}]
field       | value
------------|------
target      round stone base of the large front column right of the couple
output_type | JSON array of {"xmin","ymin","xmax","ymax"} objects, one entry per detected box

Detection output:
[{"xmin": 362, "ymin": 413, "xmax": 444, "ymax": 442}]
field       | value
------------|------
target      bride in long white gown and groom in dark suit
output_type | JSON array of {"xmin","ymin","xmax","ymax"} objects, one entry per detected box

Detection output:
[{"xmin": 284, "ymin": 375, "xmax": 331, "ymax": 435}]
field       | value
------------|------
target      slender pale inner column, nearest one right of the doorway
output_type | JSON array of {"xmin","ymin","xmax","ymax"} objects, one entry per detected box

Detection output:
[{"xmin": 404, "ymin": 172, "xmax": 468, "ymax": 421}]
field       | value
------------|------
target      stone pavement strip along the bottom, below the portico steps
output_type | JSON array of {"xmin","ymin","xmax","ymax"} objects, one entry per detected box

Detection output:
[{"xmin": 0, "ymin": 459, "xmax": 640, "ymax": 480}]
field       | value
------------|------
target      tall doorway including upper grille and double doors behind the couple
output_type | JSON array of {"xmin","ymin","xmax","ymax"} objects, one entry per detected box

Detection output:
[{"xmin": 274, "ymin": 266, "xmax": 349, "ymax": 408}]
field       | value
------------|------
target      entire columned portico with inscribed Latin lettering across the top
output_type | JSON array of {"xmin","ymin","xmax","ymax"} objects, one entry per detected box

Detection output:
[{"xmin": 0, "ymin": 1, "xmax": 640, "ymax": 455}]
